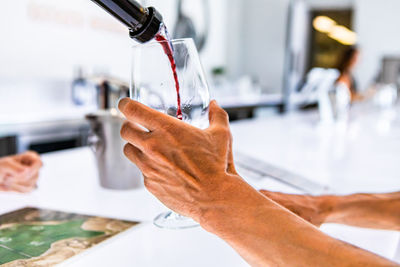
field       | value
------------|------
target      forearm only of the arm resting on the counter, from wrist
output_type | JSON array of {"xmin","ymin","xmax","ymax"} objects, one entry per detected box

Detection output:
[{"xmin": 323, "ymin": 192, "xmax": 400, "ymax": 231}]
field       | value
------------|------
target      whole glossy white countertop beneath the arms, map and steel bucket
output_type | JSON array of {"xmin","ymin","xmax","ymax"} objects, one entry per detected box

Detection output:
[{"xmin": 0, "ymin": 103, "xmax": 400, "ymax": 266}]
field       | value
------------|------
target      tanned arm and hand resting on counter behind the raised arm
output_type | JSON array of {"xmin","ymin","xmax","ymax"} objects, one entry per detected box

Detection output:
[{"xmin": 260, "ymin": 190, "xmax": 400, "ymax": 231}]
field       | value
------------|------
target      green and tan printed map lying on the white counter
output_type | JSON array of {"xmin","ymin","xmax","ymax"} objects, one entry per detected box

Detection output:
[{"xmin": 0, "ymin": 208, "xmax": 138, "ymax": 267}]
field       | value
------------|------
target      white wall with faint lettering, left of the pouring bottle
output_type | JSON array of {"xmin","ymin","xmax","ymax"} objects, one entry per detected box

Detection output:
[{"xmin": 0, "ymin": 0, "xmax": 132, "ymax": 80}]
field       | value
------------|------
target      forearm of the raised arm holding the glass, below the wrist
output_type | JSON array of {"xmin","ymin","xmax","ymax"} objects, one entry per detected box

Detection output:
[{"xmin": 201, "ymin": 180, "xmax": 396, "ymax": 266}]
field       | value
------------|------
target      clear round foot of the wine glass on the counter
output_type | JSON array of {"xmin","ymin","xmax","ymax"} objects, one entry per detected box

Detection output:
[{"xmin": 154, "ymin": 211, "xmax": 200, "ymax": 230}]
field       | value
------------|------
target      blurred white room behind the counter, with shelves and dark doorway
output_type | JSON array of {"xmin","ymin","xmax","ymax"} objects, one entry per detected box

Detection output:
[{"xmin": 0, "ymin": 0, "xmax": 400, "ymax": 155}]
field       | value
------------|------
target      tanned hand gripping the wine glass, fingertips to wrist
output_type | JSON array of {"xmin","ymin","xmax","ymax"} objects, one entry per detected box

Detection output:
[{"xmin": 119, "ymin": 99, "xmax": 246, "ymax": 222}]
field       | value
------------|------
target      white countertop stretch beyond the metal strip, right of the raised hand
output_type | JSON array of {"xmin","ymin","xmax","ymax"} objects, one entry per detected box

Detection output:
[{"xmin": 232, "ymin": 105, "xmax": 400, "ymax": 194}]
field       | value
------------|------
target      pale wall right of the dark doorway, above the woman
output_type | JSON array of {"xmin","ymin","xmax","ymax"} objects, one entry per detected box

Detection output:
[{"xmin": 354, "ymin": 0, "xmax": 400, "ymax": 89}]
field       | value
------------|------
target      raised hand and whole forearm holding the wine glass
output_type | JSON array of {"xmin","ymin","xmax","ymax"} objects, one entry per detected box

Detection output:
[{"xmin": 119, "ymin": 99, "xmax": 397, "ymax": 266}]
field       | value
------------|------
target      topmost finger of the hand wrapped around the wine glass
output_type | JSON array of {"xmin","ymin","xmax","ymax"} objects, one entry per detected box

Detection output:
[{"xmin": 118, "ymin": 98, "xmax": 179, "ymax": 131}]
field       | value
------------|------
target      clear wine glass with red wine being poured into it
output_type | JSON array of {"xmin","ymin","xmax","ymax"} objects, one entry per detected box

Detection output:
[{"xmin": 131, "ymin": 39, "xmax": 210, "ymax": 229}]
